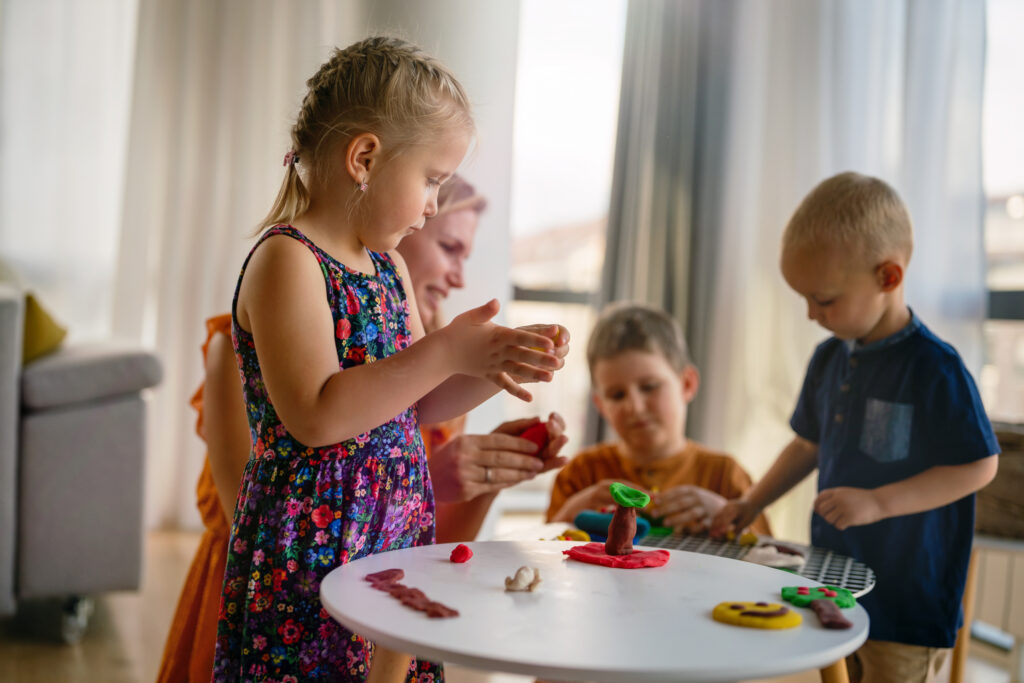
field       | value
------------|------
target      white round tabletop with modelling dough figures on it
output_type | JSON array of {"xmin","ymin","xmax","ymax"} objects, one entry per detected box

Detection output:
[{"xmin": 321, "ymin": 541, "xmax": 868, "ymax": 683}]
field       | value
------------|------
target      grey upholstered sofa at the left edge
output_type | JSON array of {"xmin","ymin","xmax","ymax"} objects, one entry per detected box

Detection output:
[{"xmin": 0, "ymin": 284, "xmax": 162, "ymax": 635}]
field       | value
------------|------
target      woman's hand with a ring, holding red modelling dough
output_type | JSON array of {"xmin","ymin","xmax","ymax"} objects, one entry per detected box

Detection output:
[{"xmin": 428, "ymin": 413, "xmax": 568, "ymax": 503}]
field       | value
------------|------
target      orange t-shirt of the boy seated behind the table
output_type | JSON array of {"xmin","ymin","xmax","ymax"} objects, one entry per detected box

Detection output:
[{"xmin": 547, "ymin": 439, "xmax": 771, "ymax": 536}]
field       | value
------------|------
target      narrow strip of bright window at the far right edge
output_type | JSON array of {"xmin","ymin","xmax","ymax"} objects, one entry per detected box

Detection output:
[{"xmin": 979, "ymin": 0, "xmax": 1024, "ymax": 423}]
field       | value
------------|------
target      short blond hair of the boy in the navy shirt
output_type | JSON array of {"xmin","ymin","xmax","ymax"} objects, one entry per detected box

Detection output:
[{"xmin": 782, "ymin": 171, "xmax": 913, "ymax": 266}]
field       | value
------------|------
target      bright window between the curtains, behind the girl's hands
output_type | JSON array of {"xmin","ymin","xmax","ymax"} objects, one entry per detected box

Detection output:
[{"xmin": 504, "ymin": 0, "xmax": 626, "ymax": 481}]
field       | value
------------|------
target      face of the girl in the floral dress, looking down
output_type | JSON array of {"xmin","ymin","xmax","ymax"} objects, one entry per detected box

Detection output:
[{"xmin": 359, "ymin": 130, "xmax": 469, "ymax": 252}]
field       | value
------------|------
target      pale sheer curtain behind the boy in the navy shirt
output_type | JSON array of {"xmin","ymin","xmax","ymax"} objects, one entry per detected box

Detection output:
[{"xmin": 608, "ymin": 0, "xmax": 985, "ymax": 540}]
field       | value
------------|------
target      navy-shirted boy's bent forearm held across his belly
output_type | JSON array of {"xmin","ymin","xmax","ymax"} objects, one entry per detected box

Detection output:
[{"xmin": 814, "ymin": 455, "xmax": 999, "ymax": 530}]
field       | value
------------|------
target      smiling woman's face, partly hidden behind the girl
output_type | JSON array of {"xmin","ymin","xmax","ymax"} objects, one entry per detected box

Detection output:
[{"xmin": 398, "ymin": 208, "xmax": 479, "ymax": 321}]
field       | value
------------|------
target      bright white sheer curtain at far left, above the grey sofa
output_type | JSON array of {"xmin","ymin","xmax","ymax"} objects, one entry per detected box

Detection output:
[{"xmin": 0, "ymin": 0, "xmax": 137, "ymax": 339}]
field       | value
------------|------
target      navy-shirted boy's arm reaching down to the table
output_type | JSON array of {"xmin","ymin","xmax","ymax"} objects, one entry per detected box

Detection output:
[{"xmin": 711, "ymin": 436, "xmax": 818, "ymax": 537}]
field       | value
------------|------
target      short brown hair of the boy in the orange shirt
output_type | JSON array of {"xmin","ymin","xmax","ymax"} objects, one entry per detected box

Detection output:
[{"xmin": 587, "ymin": 303, "xmax": 693, "ymax": 380}]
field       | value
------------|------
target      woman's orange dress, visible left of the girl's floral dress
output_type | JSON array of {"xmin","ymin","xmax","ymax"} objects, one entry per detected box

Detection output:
[{"xmin": 157, "ymin": 314, "xmax": 231, "ymax": 683}]
